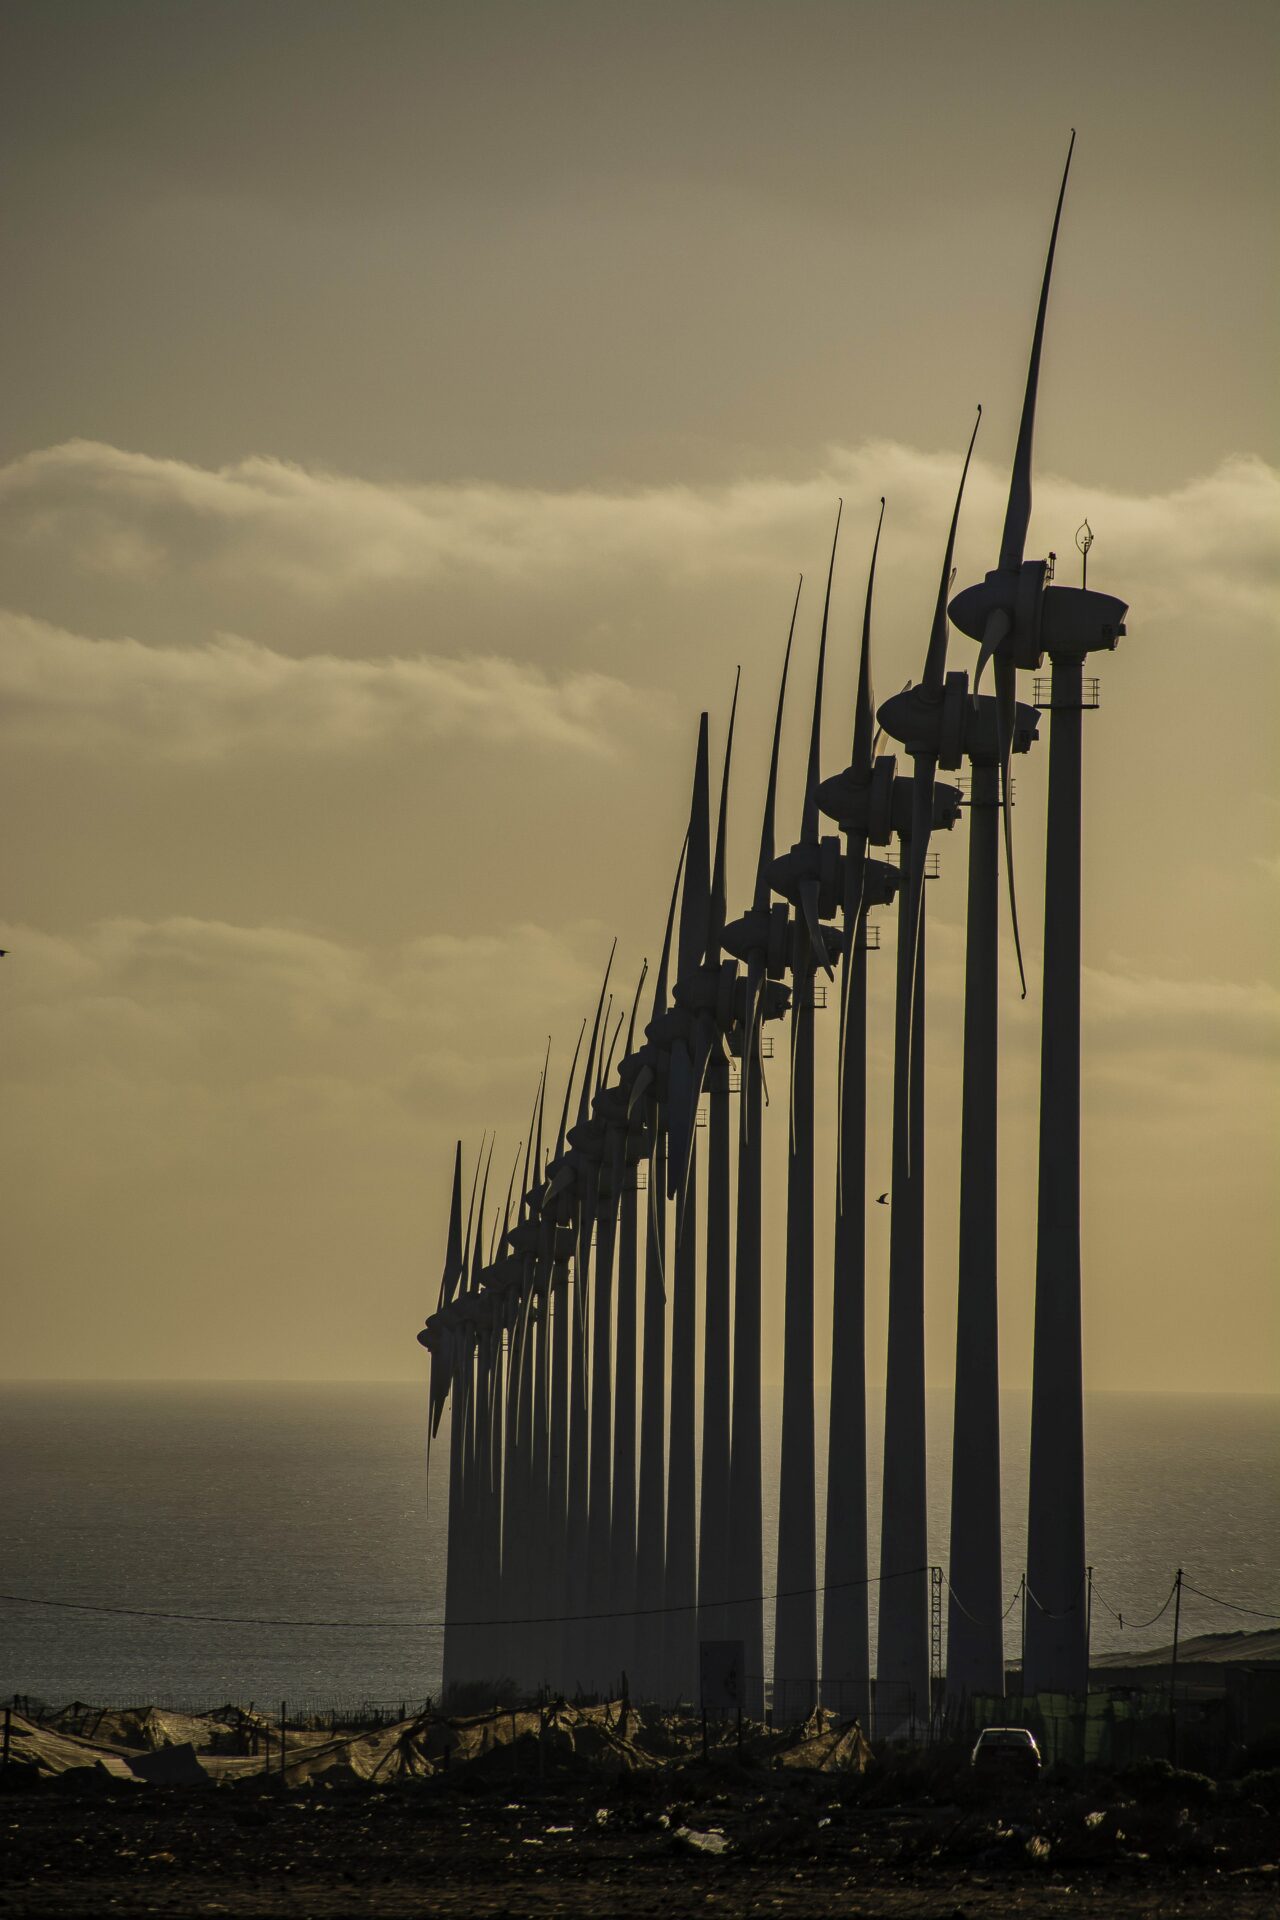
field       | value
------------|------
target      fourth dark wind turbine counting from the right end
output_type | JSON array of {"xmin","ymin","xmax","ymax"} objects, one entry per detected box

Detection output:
[{"xmin": 818, "ymin": 501, "xmax": 902, "ymax": 1726}]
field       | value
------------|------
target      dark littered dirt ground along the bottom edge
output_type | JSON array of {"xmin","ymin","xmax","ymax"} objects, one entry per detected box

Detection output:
[{"xmin": 0, "ymin": 1768, "xmax": 1280, "ymax": 1920}]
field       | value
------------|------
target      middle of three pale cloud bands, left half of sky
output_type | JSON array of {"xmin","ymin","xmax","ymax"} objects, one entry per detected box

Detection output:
[{"xmin": 0, "ymin": 612, "xmax": 639, "ymax": 760}]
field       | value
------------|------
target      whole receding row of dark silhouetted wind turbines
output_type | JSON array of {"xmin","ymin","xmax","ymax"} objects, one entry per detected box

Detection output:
[{"xmin": 418, "ymin": 134, "xmax": 1126, "ymax": 1732}]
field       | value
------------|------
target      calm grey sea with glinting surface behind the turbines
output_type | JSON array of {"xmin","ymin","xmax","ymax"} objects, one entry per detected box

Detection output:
[{"xmin": 0, "ymin": 1382, "xmax": 1280, "ymax": 1703}]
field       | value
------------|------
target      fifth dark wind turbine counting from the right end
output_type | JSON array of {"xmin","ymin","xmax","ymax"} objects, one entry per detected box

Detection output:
[{"xmin": 770, "ymin": 511, "xmax": 842, "ymax": 1718}]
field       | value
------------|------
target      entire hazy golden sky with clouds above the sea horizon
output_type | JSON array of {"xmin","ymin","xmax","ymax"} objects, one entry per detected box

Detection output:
[{"xmin": 0, "ymin": 0, "xmax": 1280, "ymax": 1390}]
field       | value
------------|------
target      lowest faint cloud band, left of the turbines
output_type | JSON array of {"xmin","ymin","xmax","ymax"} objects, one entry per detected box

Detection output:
[{"xmin": 6, "ymin": 916, "xmax": 608, "ymax": 1125}]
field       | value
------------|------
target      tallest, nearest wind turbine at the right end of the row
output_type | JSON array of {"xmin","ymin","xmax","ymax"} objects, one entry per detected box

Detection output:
[{"xmin": 950, "ymin": 134, "xmax": 1128, "ymax": 1693}]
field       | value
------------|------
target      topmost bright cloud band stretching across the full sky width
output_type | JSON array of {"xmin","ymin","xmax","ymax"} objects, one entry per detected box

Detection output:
[{"xmin": 0, "ymin": 440, "xmax": 1280, "ymax": 612}]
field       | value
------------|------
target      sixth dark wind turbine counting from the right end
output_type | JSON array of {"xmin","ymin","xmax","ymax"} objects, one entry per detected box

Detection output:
[{"xmin": 722, "ymin": 586, "xmax": 800, "ymax": 1715}]
